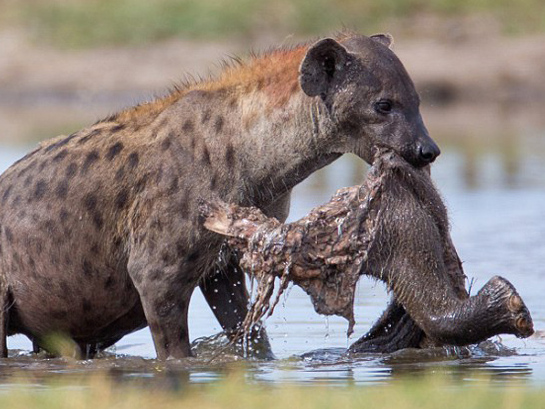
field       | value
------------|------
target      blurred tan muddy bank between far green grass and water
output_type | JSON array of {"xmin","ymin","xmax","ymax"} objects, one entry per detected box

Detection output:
[{"xmin": 0, "ymin": 31, "xmax": 545, "ymax": 143}]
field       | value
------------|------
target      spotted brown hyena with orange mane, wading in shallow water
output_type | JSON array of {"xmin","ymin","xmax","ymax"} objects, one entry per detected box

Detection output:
[{"xmin": 0, "ymin": 33, "xmax": 439, "ymax": 359}]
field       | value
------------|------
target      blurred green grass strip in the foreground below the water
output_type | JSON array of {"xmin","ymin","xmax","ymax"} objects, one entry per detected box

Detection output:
[{"xmin": 0, "ymin": 375, "xmax": 545, "ymax": 409}]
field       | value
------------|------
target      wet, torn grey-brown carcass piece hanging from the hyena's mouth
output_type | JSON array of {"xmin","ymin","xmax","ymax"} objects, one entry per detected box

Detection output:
[{"xmin": 202, "ymin": 151, "xmax": 533, "ymax": 352}]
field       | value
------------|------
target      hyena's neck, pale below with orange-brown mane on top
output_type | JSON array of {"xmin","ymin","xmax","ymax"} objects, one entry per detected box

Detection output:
[{"xmin": 176, "ymin": 46, "xmax": 339, "ymax": 206}]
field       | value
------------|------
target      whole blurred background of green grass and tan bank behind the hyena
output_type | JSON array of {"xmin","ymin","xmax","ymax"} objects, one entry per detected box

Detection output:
[{"xmin": 0, "ymin": 0, "xmax": 545, "ymax": 171}]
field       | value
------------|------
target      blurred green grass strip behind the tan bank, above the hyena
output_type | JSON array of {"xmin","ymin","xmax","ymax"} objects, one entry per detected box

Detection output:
[{"xmin": 0, "ymin": 0, "xmax": 545, "ymax": 47}]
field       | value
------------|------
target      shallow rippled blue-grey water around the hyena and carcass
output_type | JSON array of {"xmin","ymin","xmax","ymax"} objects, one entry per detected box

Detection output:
[{"xmin": 0, "ymin": 122, "xmax": 545, "ymax": 392}]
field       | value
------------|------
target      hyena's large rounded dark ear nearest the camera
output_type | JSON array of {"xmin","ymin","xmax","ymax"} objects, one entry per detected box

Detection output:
[{"xmin": 299, "ymin": 38, "xmax": 348, "ymax": 97}]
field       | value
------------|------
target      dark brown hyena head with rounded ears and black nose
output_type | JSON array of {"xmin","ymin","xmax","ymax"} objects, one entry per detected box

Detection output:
[{"xmin": 299, "ymin": 34, "xmax": 440, "ymax": 167}]
